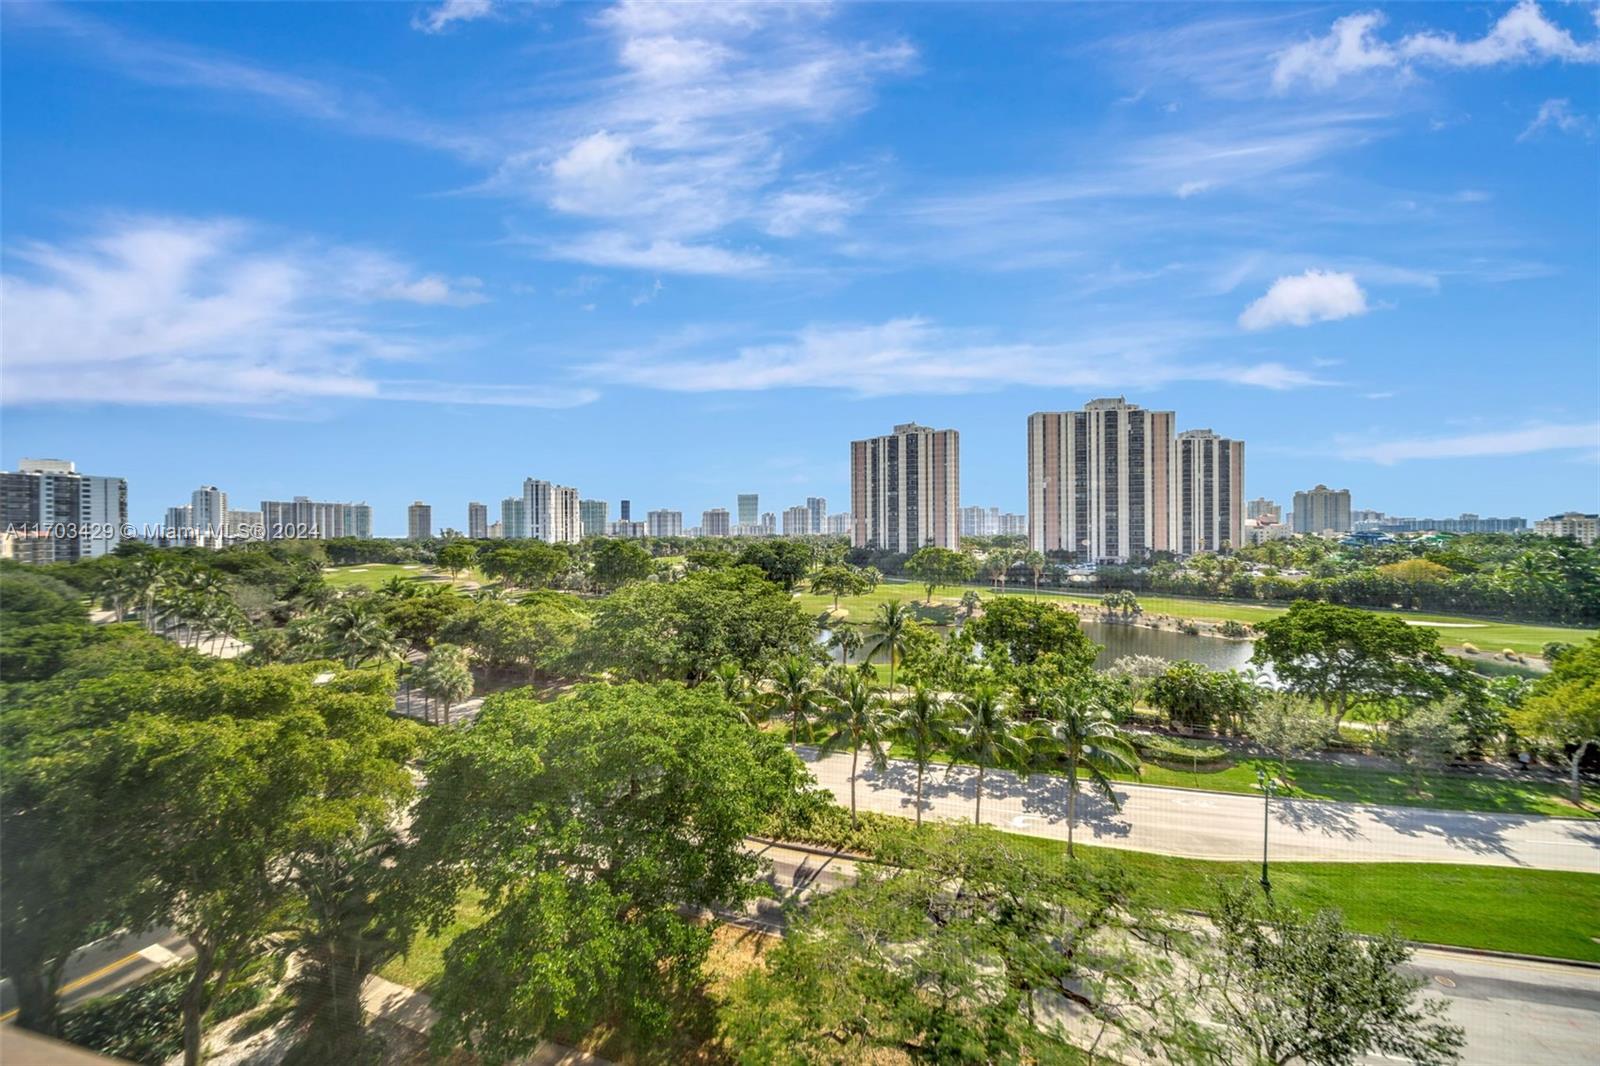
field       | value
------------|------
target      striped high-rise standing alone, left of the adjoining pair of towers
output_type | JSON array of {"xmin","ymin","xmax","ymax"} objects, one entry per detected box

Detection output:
[{"xmin": 850, "ymin": 423, "xmax": 962, "ymax": 552}]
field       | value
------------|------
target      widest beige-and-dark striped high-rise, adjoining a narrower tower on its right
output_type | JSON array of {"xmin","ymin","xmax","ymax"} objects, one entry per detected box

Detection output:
[{"xmin": 1027, "ymin": 397, "xmax": 1176, "ymax": 562}]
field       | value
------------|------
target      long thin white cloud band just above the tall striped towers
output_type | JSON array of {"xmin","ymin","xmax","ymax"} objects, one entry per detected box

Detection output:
[{"xmin": 578, "ymin": 317, "xmax": 1325, "ymax": 395}]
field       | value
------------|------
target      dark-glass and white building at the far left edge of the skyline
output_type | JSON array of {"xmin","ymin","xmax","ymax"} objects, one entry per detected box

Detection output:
[{"xmin": 0, "ymin": 459, "xmax": 128, "ymax": 562}]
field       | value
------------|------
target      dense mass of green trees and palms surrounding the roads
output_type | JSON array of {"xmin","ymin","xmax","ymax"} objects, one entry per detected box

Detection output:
[{"xmin": 0, "ymin": 541, "xmax": 1600, "ymax": 1063}]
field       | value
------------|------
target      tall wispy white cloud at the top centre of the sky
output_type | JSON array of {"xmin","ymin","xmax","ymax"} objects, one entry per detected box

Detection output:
[{"xmin": 483, "ymin": 2, "xmax": 914, "ymax": 274}]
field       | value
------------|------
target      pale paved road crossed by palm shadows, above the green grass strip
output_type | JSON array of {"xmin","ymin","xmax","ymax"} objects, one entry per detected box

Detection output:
[{"xmin": 800, "ymin": 749, "xmax": 1600, "ymax": 874}]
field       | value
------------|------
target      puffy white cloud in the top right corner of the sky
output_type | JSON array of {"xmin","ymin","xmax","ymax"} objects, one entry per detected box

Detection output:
[{"xmin": 1272, "ymin": 0, "xmax": 1600, "ymax": 93}]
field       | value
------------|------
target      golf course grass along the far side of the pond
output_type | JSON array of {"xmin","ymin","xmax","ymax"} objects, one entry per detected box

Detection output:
[{"xmin": 798, "ymin": 581, "xmax": 1595, "ymax": 655}]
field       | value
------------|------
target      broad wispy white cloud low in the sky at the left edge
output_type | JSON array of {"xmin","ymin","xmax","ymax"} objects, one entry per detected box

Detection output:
[{"xmin": 0, "ymin": 218, "xmax": 581, "ymax": 407}]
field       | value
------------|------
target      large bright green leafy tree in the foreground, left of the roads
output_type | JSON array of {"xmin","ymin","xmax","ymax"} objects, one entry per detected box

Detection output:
[{"xmin": 413, "ymin": 683, "xmax": 806, "ymax": 1061}]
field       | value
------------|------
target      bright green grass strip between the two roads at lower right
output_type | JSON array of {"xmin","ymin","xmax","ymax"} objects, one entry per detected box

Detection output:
[{"xmin": 1006, "ymin": 834, "xmax": 1600, "ymax": 962}]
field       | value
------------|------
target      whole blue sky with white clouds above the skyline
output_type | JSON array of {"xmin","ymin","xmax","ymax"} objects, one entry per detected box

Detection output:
[{"xmin": 0, "ymin": 0, "xmax": 1600, "ymax": 535}]
